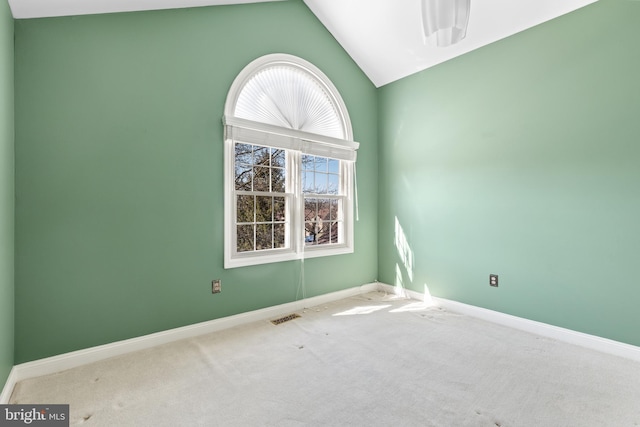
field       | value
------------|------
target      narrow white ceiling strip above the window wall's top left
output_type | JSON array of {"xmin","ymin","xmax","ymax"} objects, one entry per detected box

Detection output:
[{"xmin": 9, "ymin": 0, "xmax": 282, "ymax": 19}]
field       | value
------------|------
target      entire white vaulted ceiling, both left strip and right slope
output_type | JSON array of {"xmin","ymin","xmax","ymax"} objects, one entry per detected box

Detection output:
[{"xmin": 9, "ymin": 0, "xmax": 597, "ymax": 87}]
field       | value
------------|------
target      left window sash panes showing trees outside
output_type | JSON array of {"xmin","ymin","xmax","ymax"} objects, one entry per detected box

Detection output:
[{"xmin": 235, "ymin": 143, "xmax": 287, "ymax": 252}]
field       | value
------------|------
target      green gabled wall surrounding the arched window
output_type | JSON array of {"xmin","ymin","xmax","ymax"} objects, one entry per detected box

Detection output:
[{"xmin": 15, "ymin": 0, "xmax": 378, "ymax": 363}]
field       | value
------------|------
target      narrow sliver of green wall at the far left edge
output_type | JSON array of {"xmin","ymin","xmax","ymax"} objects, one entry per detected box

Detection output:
[{"xmin": 0, "ymin": 0, "xmax": 14, "ymax": 390}]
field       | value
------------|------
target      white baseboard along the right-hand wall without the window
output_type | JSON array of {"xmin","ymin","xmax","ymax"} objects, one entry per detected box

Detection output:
[{"xmin": 379, "ymin": 284, "xmax": 640, "ymax": 362}]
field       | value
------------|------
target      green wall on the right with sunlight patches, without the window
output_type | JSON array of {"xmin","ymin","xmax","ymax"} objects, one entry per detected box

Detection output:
[{"xmin": 378, "ymin": 0, "xmax": 640, "ymax": 345}]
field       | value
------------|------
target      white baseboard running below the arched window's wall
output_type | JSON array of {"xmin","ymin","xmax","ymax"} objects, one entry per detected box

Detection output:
[{"xmin": 5, "ymin": 283, "xmax": 379, "ymax": 394}]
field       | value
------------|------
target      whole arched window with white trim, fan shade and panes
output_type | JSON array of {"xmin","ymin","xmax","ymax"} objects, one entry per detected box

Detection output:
[{"xmin": 224, "ymin": 54, "xmax": 359, "ymax": 268}]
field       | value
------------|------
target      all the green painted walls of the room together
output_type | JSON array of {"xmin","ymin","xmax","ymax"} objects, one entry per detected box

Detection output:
[{"xmin": 10, "ymin": 0, "xmax": 640, "ymax": 366}]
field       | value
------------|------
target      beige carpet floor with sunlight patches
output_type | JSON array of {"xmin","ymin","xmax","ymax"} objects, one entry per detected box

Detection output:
[{"xmin": 11, "ymin": 292, "xmax": 640, "ymax": 427}]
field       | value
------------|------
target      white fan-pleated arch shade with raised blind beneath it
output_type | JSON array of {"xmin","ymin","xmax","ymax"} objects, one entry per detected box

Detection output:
[{"xmin": 224, "ymin": 54, "xmax": 359, "ymax": 161}]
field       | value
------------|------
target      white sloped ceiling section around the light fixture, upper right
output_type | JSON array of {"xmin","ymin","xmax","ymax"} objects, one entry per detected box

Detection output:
[{"xmin": 304, "ymin": 0, "xmax": 598, "ymax": 87}]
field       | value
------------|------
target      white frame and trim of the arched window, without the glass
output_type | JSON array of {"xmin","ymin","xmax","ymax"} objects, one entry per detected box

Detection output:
[{"xmin": 223, "ymin": 54, "xmax": 359, "ymax": 268}]
